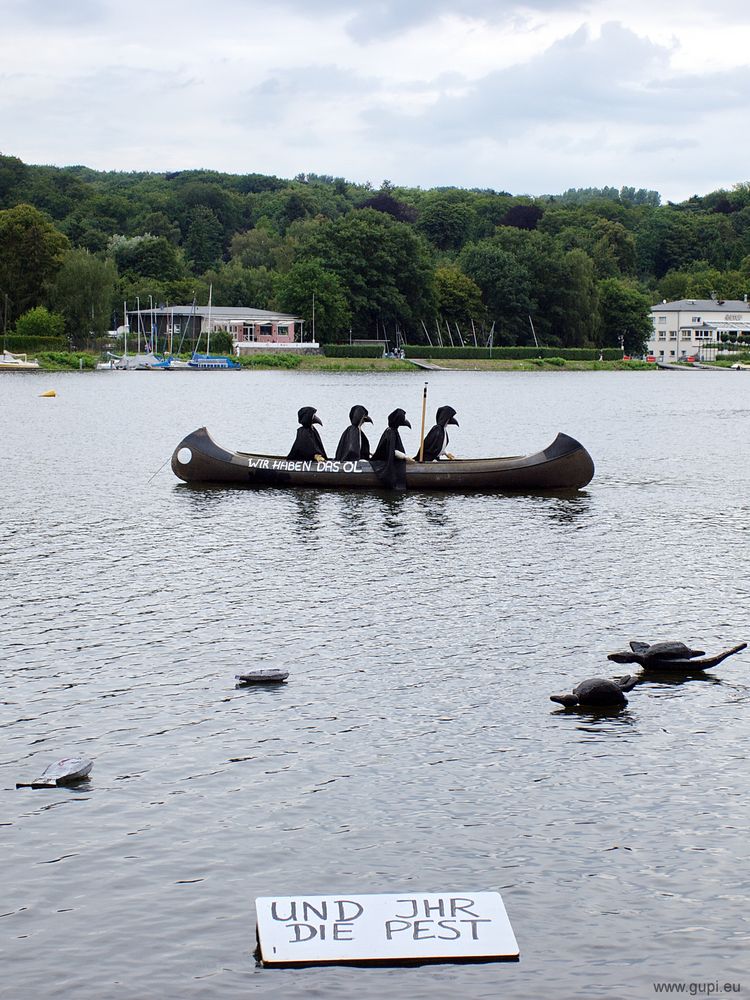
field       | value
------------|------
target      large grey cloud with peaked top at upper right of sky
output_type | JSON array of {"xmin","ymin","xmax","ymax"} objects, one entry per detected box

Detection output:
[{"xmin": 364, "ymin": 24, "xmax": 750, "ymax": 142}]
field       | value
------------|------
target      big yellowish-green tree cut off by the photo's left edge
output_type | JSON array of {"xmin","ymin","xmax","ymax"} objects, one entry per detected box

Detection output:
[{"xmin": 0, "ymin": 205, "xmax": 70, "ymax": 320}]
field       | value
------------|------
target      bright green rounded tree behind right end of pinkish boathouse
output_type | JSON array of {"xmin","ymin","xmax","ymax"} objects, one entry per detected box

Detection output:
[{"xmin": 277, "ymin": 260, "xmax": 352, "ymax": 343}]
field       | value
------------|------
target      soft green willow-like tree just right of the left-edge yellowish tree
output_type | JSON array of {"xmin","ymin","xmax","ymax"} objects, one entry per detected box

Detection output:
[{"xmin": 51, "ymin": 250, "xmax": 117, "ymax": 343}]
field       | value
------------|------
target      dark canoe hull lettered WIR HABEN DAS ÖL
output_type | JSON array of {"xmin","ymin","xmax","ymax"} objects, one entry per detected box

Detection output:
[{"xmin": 172, "ymin": 427, "xmax": 594, "ymax": 493}]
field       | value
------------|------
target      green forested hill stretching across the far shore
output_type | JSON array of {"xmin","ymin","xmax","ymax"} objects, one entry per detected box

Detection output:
[{"xmin": 0, "ymin": 148, "xmax": 750, "ymax": 350}]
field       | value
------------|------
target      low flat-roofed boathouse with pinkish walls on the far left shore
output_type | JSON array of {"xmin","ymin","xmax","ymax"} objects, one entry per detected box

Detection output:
[{"xmin": 128, "ymin": 305, "xmax": 320, "ymax": 355}]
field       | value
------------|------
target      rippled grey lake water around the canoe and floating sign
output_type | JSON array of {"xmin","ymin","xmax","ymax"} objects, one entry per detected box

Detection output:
[{"xmin": 0, "ymin": 372, "xmax": 750, "ymax": 1000}]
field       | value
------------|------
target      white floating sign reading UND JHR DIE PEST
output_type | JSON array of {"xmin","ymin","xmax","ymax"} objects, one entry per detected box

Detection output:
[{"xmin": 255, "ymin": 892, "xmax": 519, "ymax": 965}]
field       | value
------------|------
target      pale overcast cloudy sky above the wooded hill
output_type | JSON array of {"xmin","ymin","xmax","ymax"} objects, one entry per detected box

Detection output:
[{"xmin": 0, "ymin": 0, "xmax": 750, "ymax": 201}]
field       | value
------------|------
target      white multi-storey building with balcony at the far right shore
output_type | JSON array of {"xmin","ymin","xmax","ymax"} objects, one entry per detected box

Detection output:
[{"xmin": 648, "ymin": 296, "xmax": 750, "ymax": 361}]
